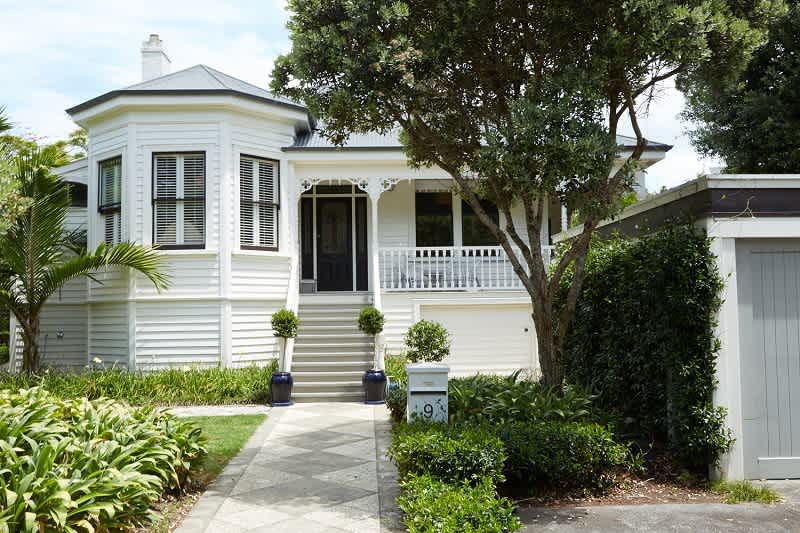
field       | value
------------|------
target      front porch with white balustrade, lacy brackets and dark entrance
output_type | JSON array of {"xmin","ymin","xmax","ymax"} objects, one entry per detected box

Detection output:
[{"xmin": 297, "ymin": 178, "xmax": 561, "ymax": 296}]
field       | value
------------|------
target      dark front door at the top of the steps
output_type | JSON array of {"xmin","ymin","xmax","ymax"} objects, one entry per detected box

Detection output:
[{"xmin": 317, "ymin": 198, "xmax": 353, "ymax": 291}]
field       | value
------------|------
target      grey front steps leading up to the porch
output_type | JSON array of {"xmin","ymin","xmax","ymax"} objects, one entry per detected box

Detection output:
[{"xmin": 292, "ymin": 293, "xmax": 375, "ymax": 402}]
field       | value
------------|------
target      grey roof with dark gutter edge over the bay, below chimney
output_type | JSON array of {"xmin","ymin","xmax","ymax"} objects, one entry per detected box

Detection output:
[{"xmin": 67, "ymin": 65, "xmax": 308, "ymax": 118}]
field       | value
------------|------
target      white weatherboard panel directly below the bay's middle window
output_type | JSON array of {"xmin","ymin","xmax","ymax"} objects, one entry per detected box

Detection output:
[{"xmin": 135, "ymin": 301, "xmax": 220, "ymax": 370}]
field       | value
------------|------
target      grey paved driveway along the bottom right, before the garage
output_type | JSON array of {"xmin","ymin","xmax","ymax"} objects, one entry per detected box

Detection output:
[{"xmin": 520, "ymin": 481, "xmax": 800, "ymax": 533}]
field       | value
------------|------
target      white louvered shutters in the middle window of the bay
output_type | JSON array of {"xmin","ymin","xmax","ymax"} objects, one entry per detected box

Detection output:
[{"xmin": 153, "ymin": 154, "xmax": 206, "ymax": 246}]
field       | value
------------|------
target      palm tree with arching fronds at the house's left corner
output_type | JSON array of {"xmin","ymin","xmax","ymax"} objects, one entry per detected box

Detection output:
[{"xmin": 0, "ymin": 146, "xmax": 168, "ymax": 372}]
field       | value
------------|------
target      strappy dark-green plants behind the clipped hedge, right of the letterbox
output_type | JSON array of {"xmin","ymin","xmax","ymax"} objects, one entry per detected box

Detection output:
[{"xmin": 448, "ymin": 372, "xmax": 601, "ymax": 425}]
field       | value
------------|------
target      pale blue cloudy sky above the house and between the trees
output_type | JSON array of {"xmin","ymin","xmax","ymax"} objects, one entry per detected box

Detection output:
[{"xmin": 0, "ymin": 0, "xmax": 719, "ymax": 191}]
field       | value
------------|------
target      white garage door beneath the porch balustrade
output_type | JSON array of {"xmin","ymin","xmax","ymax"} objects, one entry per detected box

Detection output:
[{"xmin": 420, "ymin": 304, "xmax": 536, "ymax": 376}]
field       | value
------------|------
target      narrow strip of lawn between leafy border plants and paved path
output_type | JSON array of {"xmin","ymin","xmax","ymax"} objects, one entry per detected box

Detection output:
[{"xmin": 142, "ymin": 415, "xmax": 266, "ymax": 533}]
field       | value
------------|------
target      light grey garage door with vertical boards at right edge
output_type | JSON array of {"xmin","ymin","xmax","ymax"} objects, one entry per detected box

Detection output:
[{"xmin": 736, "ymin": 240, "xmax": 800, "ymax": 478}]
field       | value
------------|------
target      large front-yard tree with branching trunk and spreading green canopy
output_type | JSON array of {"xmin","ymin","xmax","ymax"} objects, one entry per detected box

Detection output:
[{"xmin": 273, "ymin": 0, "xmax": 781, "ymax": 384}]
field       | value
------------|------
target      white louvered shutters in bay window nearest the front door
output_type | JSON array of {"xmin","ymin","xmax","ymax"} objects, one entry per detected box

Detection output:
[{"xmin": 239, "ymin": 157, "xmax": 278, "ymax": 248}]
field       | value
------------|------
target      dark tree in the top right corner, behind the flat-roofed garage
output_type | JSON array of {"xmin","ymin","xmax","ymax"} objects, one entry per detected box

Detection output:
[{"xmin": 684, "ymin": 0, "xmax": 800, "ymax": 173}]
